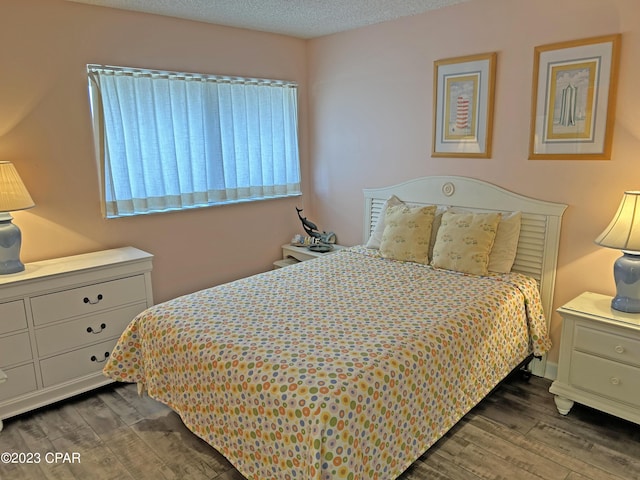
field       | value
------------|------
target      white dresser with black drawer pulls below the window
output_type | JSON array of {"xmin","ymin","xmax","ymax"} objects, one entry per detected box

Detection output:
[{"xmin": 0, "ymin": 247, "xmax": 153, "ymax": 429}]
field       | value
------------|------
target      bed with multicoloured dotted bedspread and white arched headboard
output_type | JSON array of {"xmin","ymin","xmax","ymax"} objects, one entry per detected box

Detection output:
[{"xmin": 104, "ymin": 176, "xmax": 566, "ymax": 480}]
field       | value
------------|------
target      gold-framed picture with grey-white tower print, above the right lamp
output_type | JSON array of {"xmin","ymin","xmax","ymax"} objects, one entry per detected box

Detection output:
[{"xmin": 529, "ymin": 35, "xmax": 620, "ymax": 160}]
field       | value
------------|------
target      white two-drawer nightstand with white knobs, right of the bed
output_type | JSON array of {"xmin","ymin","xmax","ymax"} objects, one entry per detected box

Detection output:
[{"xmin": 549, "ymin": 292, "xmax": 640, "ymax": 424}]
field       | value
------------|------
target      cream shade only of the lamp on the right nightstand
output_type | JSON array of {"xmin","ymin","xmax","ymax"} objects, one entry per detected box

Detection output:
[{"xmin": 596, "ymin": 191, "xmax": 640, "ymax": 252}]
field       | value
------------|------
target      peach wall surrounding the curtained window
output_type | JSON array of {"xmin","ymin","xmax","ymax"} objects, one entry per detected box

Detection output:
[{"xmin": 0, "ymin": 0, "xmax": 309, "ymax": 301}]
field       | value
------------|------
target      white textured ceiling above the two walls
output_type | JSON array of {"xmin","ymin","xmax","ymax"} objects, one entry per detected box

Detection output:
[{"xmin": 68, "ymin": 0, "xmax": 471, "ymax": 38}]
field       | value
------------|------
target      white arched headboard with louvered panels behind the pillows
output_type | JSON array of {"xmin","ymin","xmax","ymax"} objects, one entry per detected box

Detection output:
[{"xmin": 364, "ymin": 176, "xmax": 567, "ymax": 376}]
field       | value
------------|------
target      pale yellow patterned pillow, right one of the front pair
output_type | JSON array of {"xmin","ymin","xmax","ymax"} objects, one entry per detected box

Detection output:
[{"xmin": 431, "ymin": 212, "xmax": 502, "ymax": 275}]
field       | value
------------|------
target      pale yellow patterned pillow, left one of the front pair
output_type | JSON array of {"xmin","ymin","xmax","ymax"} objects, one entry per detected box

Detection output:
[{"xmin": 380, "ymin": 204, "xmax": 436, "ymax": 264}]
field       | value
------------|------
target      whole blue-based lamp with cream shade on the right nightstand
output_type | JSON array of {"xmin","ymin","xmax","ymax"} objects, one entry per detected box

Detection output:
[{"xmin": 596, "ymin": 191, "xmax": 640, "ymax": 313}]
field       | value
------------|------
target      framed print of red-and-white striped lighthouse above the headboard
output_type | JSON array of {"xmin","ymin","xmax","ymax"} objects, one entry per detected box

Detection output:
[{"xmin": 431, "ymin": 52, "xmax": 497, "ymax": 158}]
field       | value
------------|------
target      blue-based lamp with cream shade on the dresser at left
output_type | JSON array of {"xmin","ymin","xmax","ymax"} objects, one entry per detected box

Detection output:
[{"xmin": 0, "ymin": 161, "xmax": 35, "ymax": 275}]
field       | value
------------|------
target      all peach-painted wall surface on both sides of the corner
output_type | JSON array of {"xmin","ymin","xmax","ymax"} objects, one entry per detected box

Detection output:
[{"xmin": 0, "ymin": 0, "xmax": 640, "ymax": 361}]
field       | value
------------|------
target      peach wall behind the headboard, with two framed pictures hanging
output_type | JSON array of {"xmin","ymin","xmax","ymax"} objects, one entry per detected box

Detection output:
[{"xmin": 307, "ymin": 0, "xmax": 640, "ymax": 362}]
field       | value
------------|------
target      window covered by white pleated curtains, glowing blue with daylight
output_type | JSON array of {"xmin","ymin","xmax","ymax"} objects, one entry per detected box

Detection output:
[{"xmin": 87, "ymin": 65, "xmax": 300, "ymax": 218}]
